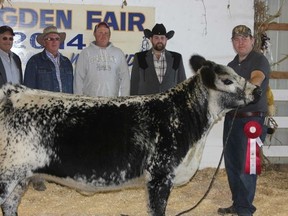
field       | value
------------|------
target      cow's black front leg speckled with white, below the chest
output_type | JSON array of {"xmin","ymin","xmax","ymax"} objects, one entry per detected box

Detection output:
[{"xmin": 147, "ymin": 175, "xmax": 173, "ymax": 216}]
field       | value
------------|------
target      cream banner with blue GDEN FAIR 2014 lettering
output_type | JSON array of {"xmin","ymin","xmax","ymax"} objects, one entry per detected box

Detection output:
[{"xmin": 0, "ymin": 3, "xmax": 155, "ymax": 69}]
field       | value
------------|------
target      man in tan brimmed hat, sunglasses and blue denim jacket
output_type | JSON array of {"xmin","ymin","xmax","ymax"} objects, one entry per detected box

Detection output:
[{"xmin": 24, "ymin": 26, "xmax": 73, "ymax": 94}]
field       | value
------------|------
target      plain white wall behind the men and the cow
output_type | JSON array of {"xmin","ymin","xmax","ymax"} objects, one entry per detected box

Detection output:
[{"xmin": 6, "ymin": 0, "xmax": 254, "ymax": 168}]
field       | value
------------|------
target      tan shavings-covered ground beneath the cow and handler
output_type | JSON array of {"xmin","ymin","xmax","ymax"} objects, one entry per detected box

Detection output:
[{"xmin": 0, "ymin": 168, "xmax": 288, "ymax": 216}]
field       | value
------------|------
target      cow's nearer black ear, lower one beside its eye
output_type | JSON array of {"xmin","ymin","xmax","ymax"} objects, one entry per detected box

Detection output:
[{"xmin": 200, "ymin": 61, "xmax": 216, "ymax": 89}]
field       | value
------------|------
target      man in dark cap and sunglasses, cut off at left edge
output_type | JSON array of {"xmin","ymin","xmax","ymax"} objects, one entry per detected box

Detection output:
[{"xmin": 0, "ymin": 26, "xmax": 23, "ymax": 87}]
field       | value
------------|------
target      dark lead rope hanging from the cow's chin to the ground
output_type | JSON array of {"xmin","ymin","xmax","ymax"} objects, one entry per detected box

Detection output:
[{"xmin": 175, "ymin": 106, "xmax": 238, "ymax": 216}]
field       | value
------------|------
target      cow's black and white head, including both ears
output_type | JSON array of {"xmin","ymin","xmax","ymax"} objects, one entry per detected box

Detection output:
[{"xmin": 190, "ymin": 55, "xmax": 261, "ymax": 111}]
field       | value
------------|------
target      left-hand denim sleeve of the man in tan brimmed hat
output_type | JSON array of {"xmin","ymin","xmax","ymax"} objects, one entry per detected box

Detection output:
[{"xmin": 23, "ymin": 56, "xmax": 38, "ymax": 89}]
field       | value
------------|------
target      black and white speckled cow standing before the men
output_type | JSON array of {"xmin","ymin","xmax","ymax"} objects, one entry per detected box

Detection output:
[{"xmin": 0, "ymin": 56, "xmax": 257, "ymax": 216}]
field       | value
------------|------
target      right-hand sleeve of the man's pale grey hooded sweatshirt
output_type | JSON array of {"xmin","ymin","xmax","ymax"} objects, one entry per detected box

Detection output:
[{"xmin": 119, "ymin": 51, "xmax": 130, "ymax": 96}]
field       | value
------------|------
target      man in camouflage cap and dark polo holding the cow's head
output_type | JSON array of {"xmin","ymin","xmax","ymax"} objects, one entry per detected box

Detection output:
[{"xmin": 218, "ymin": 25, "xmax": 270, "ymax": 216}]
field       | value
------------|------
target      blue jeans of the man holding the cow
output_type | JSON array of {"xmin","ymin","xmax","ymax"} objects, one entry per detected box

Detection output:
[{"xmin": 223, "ymin": 115, "xmax": 266, "ymax": 215}]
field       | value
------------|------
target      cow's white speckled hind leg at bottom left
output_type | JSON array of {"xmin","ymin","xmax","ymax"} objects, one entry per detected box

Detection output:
[{"xmin": 1, "ymin": 180, "xmax": 29, "ymax": 216}]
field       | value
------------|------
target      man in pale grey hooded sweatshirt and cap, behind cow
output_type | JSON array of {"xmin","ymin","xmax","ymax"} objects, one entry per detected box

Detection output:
[{"xmin": 74, "ymin": 22, "xmax": 130, "ymax": 97}]
